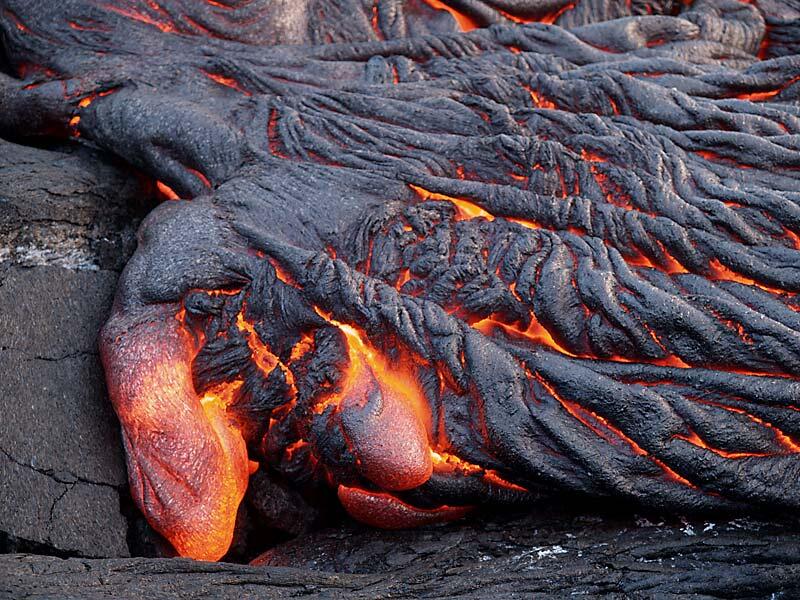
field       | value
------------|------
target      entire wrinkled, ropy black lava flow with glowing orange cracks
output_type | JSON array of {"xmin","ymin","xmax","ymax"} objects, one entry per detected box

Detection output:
[{"xmin": 0, "ymin": 0, "xmax": 800, "ymax": 559}]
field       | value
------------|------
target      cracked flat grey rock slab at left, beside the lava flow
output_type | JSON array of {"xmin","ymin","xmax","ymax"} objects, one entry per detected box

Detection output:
[{"xmin": 0, "ymin": 140, "xmax": 153, "ymax": 556}]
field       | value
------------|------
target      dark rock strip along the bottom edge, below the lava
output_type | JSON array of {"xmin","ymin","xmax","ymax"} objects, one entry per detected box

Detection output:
[{"xmin": 0, "ymin": 510, "xmax": 800, "ymax": 599}]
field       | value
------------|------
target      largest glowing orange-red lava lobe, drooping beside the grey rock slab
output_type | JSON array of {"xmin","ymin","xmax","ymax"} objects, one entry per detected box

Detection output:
[{"xmin": 101, "ymin": 306, "xmax": 248, "ymax": 560}]
